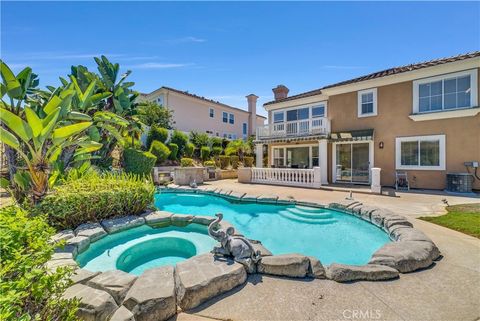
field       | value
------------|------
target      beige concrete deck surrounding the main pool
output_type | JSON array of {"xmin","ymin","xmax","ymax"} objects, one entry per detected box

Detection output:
[{"xmin": 177, "ymin": 180, "xmax": 480, "ymax": 321}]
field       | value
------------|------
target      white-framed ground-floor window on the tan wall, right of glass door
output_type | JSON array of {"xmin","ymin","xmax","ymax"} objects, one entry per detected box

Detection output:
[{"xmin": 395, "ymin": 135, "xmax": 445, "ymax": 170}]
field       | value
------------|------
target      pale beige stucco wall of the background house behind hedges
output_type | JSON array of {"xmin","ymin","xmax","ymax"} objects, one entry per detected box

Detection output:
[{"xmin": 148, "ymin": 90, "xmax": 265, "ymax": 138}]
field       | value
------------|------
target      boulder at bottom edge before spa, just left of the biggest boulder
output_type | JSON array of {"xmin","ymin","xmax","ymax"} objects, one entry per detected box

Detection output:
[{"xmin": 123, "ymin": 266, "xmax": 177, "ymax": 321}]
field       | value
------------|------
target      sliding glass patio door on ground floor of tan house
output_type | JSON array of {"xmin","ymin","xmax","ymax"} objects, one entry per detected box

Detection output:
[{"xmin": 335, "ymin": 142, "xmax": 370, "ymax": 184}]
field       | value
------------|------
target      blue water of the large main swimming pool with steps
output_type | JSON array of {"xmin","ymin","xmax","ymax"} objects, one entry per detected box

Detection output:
[{"xmin": 155, "ymin": 193, "xmax": 390, "ymax": 264}]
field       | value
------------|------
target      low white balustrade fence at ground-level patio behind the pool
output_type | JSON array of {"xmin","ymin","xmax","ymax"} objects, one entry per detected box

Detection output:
[{"xmin": 251, "ymin": 167, "xmax": 321, "ymax": 188}]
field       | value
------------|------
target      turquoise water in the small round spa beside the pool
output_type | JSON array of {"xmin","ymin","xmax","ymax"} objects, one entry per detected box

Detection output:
[{"xmin": 76, "ymin": 224, "xmax": 216, "ymax": 275}]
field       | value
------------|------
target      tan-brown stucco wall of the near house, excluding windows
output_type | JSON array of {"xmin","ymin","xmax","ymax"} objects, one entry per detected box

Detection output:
[{"xmin": 328, "ymin": 66, "xmax": 480, "ymax": 189}]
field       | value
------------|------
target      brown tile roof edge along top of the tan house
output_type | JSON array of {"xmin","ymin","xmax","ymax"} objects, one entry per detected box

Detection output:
[{"xmin": 263, "ymin": 51, "xmax": 480, "ymax": 106}]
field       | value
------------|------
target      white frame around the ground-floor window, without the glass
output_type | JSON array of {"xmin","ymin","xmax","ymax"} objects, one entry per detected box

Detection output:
[{"xmin": 395, "ymin": 134, "xmax": 446, "ymax": 171}]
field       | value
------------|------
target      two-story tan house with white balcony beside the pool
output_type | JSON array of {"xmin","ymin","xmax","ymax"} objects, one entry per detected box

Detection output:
[{"xmin": 256, "ymin": 52, "xmax": 480, "ymax": 189}]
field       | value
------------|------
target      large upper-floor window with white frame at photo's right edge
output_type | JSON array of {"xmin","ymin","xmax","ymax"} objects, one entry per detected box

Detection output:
[{"xmin": 413, "ymin": 69, "xmax": 477, "ymax": 113}]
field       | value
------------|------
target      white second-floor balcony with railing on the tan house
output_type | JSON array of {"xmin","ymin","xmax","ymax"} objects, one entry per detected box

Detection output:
[{"xmin": 257, "ymin": 117, "xmax": 330, "ymax": 140}]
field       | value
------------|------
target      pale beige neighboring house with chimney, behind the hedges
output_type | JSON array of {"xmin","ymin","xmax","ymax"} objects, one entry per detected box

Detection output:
[{"xmin": 140, "ymin": 87, "xmax": 266, "ymax": 139}]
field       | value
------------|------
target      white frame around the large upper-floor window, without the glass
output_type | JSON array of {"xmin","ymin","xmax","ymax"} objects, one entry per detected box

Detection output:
[{"xmin": 413, "ymin": 69, "xmax": 478, "ymax": 114}]
